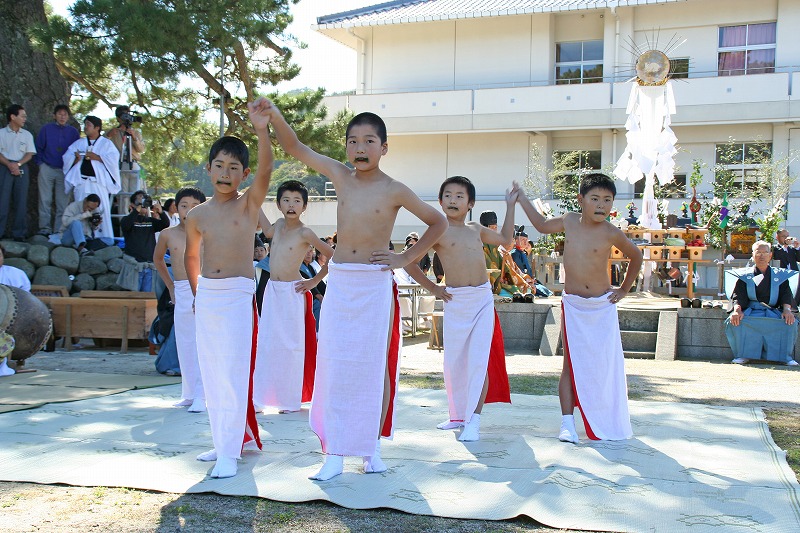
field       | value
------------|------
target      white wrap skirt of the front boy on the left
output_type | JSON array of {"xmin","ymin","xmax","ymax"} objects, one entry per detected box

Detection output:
[{"xmin": 195, "ymin": 276, "xmax": 257, "ymax": 458}]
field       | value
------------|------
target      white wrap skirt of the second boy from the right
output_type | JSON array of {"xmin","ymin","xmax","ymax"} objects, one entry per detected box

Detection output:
[{"xmin": 442, "ymin": 281, "xmax": 494, "ymax": 422}]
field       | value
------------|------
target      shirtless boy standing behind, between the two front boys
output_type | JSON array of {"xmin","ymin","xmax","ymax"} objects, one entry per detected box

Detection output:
[{"xmin": 253, "ymin": 180, "xmax": 333, "ymax": 413}]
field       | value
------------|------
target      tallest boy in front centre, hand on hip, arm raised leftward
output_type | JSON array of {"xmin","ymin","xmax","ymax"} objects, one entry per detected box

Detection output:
[{"xmin": 272, "ymin": 102, "xmax": 447, "ymax": 480}]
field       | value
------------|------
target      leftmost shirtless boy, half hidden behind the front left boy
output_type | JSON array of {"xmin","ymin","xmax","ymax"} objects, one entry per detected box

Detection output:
[{"xmin": 153, "ymin": 187, "xmax": 206, "ymax": 413}]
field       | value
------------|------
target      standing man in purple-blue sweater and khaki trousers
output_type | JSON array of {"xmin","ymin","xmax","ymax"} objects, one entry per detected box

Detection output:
[{"xmin": 36, "ymin": 104, "xmax": 81, "ymax": 235}]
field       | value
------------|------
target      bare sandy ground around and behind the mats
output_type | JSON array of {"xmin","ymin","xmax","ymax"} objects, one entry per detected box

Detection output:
[{"xmin": 0, "ymin": 337, "xmax": 800, "ymax": 533}]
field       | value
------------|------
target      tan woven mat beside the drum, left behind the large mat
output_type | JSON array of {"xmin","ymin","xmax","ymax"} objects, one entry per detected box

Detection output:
[{"xmin": 0, "ymin": 370, "xmax": 180, "ymax": 413}]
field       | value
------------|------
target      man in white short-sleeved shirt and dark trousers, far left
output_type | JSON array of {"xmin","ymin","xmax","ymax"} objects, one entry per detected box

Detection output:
[{"xmin": 0, "ymin": 104, "xmax": 36, "ymax": 241}]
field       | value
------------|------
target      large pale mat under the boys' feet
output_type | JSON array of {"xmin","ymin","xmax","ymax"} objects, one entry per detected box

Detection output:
[{"xmin": 0, "ymin": 386, "xmax": 800, "ymax": 532}]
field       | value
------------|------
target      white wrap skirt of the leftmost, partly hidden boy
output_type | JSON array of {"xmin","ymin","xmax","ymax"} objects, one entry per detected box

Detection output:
[{"xmin": 174, "ymin": 279, "xmax": 206, "ymax": 400}]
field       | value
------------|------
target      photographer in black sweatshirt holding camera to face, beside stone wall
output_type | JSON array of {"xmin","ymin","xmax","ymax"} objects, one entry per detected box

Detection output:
[{"xmin": 117, "ymin": 191, "xmax": 169, "ymax": 292}]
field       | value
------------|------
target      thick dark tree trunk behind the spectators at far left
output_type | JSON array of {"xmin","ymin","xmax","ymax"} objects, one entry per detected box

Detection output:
[{"xmin": 0, "ymin": 0, "xmax": 70, "ymax": 234}]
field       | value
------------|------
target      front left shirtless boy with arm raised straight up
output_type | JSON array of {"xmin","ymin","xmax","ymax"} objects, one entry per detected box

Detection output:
[{"xmin": 184, "ymin": 98, "xmax": 272, "ymax": 477}]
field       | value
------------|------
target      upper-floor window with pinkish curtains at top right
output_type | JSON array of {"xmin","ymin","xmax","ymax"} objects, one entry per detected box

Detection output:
[{"xmin": 717, "ymin": 22, "xmax": 776, "ymax": 76}]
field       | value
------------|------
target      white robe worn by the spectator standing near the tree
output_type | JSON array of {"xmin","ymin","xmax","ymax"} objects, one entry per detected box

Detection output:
[{"xmin": 62, "ymin": 137, "xmax": 120, "ymax": 239}]
